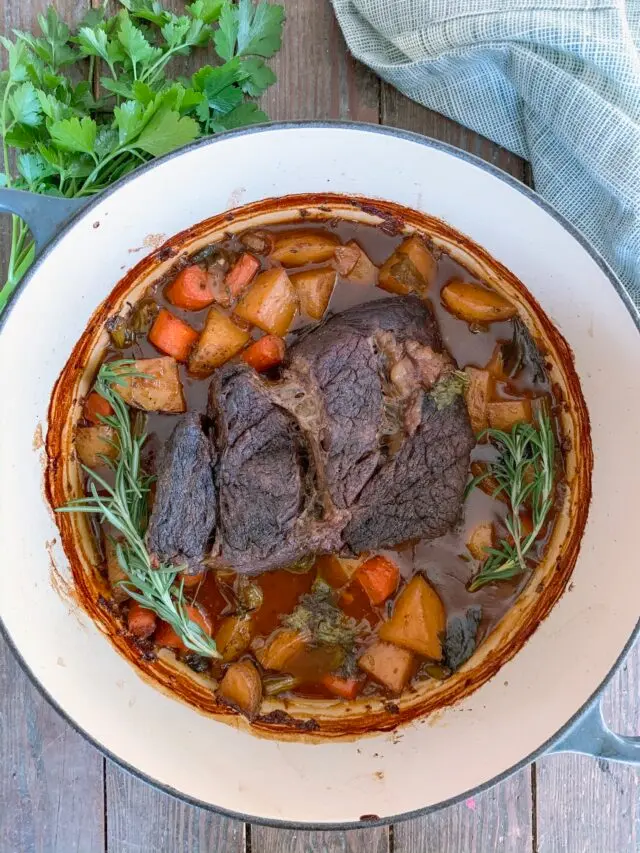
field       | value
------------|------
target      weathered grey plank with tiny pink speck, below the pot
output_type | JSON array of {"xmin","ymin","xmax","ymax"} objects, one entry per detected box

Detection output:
[{"xmin": 394, "ymin": 768, "xmax": 533, "ymax": 853}]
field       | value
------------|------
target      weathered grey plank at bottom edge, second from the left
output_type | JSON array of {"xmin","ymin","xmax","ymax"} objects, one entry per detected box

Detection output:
[{"xmin": 105, "ymin": 761, "xmax": 245, "ymax": 853}]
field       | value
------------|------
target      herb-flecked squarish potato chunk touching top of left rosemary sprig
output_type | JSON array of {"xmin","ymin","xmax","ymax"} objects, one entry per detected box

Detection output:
[{"xmin": 115, "ymin": 356, "xmax": 187, "ymax": 414}]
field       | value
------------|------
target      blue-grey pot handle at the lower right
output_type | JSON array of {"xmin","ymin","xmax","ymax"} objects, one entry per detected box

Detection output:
[{"xmin": 547, "ymin": 699, "xmax": 640, "ymax": 764}]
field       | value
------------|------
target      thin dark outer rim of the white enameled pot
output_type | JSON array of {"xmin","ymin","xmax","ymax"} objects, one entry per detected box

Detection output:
[{"xmin": 0, "ymin": 121, "xmax": 640, "ymax": 830}]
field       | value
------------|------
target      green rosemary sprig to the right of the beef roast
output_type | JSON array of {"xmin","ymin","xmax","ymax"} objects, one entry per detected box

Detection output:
[{"xmin": 467, "ymin": 412, "xmax": 555, "ymax": 592}]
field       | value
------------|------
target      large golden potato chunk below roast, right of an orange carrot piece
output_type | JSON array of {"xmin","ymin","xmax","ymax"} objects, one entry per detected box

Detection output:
[{"xmin": 378, "ymin": 575, "xmax": 446, "ymax": 661}]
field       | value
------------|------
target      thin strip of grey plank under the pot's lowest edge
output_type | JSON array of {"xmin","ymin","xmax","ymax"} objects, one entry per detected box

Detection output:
[{"xmin": 250, "ymin": 826, "xmax": 390, "ymax": 853}]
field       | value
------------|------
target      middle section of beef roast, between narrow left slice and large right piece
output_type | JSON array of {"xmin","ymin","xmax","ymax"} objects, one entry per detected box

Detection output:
[{"xmin": 209, "ymin": 364, "xmax": 341, "ymax": 573}]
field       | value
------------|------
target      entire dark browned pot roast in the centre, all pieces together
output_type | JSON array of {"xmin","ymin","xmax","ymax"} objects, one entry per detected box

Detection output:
[{"xmin": 147, "ymin": 296, "xmax": 475, "ymax": 574}]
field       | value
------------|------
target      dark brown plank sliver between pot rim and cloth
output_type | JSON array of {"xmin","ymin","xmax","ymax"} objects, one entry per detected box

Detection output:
[{"xmin": 380, "ymin": 83, "xmax": 527, "ymax": 181}]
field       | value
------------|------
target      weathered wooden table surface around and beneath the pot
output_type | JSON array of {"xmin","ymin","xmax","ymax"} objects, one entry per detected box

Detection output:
[{"xmin": 0, "ymin": 0, "xmax": 640, "ymax": 853}]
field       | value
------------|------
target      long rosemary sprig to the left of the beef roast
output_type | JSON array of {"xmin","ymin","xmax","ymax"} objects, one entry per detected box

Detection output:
[{"xmin": 58, "ymin": 359, "xmax": 220, "ymax": 658}]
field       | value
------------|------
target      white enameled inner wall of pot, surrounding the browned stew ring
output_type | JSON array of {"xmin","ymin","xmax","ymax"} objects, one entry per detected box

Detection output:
[{"xmin": 0, "ymin": 126, "xmax": 640, "ymax": 824}]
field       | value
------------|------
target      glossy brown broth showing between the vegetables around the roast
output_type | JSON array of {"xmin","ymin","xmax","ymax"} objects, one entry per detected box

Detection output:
[{"xmin": 92, "ymin": 220, "xmax": 564, "ymax": 698}]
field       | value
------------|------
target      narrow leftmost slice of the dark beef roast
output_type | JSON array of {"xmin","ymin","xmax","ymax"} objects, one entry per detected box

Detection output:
[{"xmin": 146, "ymin": 412, "xmax": 216, "ymax": 566}]
